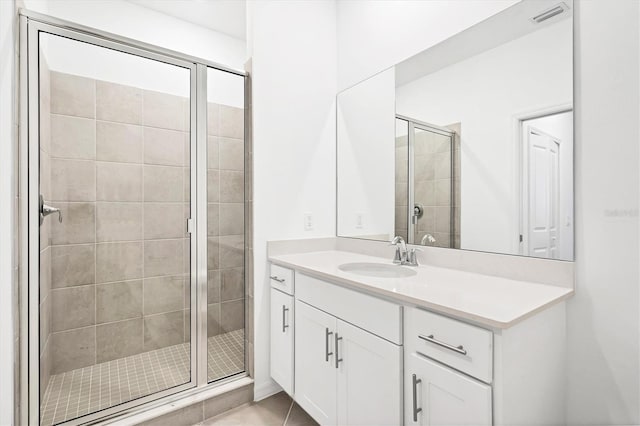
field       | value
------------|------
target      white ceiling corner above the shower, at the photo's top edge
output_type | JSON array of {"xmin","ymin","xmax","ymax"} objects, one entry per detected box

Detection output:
[{"xmin": 128, "ymin": 0, "xmax": 246, "ymax": 40}]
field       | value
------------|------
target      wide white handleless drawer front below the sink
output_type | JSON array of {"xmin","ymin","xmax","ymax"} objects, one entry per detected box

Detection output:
[{"xmin": 296, "ymin": 273, "xmax": 402, "ymax": 345}]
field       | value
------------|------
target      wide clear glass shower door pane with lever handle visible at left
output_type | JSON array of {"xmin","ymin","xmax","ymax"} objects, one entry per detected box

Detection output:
[{"xmin": 38, "ymin": 32, "xmax": 195, "ymax": 425}]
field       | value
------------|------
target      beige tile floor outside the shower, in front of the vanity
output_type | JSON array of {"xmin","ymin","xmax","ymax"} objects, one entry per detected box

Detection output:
[{"xmin": 199, "ymin": 392, "xmax": 318, "ymax": 426}]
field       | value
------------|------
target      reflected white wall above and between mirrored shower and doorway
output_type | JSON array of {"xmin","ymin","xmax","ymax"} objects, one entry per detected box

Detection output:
[{"xmin": 396, "ymin": 19, "xmax": 573, "ymax": 254}]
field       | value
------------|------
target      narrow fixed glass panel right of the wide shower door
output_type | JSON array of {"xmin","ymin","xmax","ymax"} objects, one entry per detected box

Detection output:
[{"xmin": 206, "ymin": 68, "xmax": 246, "ymax": 382}]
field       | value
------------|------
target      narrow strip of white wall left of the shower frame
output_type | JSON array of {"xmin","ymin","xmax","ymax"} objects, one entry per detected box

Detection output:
[{"xmin": 0, "ymin": 1, "xmax": 16, "ymax": 425}]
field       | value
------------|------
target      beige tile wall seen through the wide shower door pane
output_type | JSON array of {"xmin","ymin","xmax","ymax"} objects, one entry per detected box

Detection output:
[{"xmin": 48, "ymin": 72, "xmax": 192, "ymax": 374}]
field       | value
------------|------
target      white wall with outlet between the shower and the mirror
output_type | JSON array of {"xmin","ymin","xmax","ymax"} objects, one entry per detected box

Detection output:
[{"xmin": 248, "ymin": 1, "xmax": 336, "ymax": 399}]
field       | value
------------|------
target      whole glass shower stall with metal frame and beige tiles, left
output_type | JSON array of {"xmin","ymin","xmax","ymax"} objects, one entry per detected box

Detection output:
[{"xmin": 20, "ymin": 13, "xmax": 250, "ymax": 425}]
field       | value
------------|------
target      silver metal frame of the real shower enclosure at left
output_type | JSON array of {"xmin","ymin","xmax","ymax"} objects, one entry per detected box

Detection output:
[{"xmin": 18, "ymin": 10, "xmax": 250, "ymax": 425}]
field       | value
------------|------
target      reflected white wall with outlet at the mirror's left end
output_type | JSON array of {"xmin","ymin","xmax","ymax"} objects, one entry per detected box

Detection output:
[{"xmin": 337, "ymin": 68, "xmax": 396, "ymax": 240}]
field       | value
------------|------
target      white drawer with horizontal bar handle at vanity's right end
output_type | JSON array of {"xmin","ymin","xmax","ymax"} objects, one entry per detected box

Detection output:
[{"xmin": 404, "ymin": 308, "xmax": 493, "ymax": 383}]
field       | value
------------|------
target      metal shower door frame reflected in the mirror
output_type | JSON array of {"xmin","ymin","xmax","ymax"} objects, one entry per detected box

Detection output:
[{"xmin": 396, "ymin": 114, "xmax": 456, "ymax": 248}]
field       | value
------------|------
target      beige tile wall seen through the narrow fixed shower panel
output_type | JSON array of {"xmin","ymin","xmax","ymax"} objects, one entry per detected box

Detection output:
[{"xmin": 207, "ymin": 103, "xmax": 245, "ymax": 337}]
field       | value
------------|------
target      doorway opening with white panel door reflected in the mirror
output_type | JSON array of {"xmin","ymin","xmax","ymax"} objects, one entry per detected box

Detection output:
[{"xmin": 521, "ymin": 111, "xmax": 573, "ymax": 259}]
